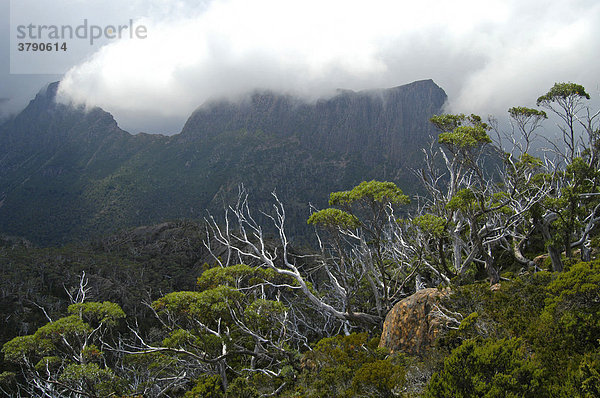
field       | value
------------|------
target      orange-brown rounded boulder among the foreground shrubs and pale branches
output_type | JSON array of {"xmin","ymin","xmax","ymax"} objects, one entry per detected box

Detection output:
[{"xmin": 379, "ymin": 288, "xmax": 450, "ymax": 355}]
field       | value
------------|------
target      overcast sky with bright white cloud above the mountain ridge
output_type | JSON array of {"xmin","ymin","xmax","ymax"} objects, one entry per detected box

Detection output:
[{"xmin": 0, "ymin": 0, "xmax": 600, "ymax": 133}]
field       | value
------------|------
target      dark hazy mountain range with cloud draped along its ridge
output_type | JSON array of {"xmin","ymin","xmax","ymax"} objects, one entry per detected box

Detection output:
[{"xmin": 0, "ymin": 80, "xmax": 446, "ymax": 245}]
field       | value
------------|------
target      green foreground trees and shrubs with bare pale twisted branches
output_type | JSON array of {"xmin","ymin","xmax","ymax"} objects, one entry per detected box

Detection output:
[{"xmin": 0, "ymin": 83, "xmax": 600, "ymax": 398}]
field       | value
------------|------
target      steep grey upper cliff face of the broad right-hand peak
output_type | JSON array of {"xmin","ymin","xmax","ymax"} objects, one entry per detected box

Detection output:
[{"xmin": 181, "ymin": 80, "xmax": 446, "ymax": 167}]
